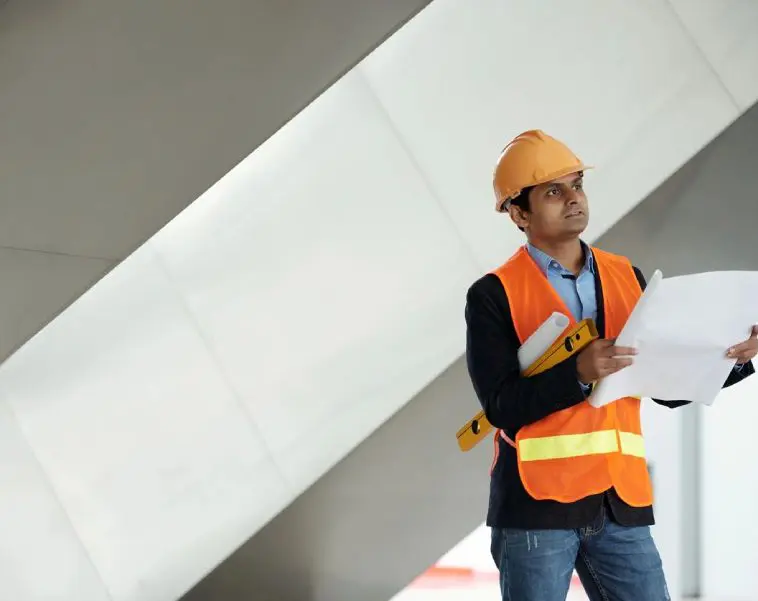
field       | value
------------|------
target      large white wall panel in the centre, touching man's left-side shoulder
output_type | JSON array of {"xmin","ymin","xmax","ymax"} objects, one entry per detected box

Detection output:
[{"xmin": 152, "ymin": 73, "xmax": 478, "ymax": 490}]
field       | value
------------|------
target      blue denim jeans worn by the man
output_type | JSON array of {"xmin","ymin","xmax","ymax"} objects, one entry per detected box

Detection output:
[{"xmin": 491, "ymin": 510, "xmax": 670, "ymax": 601}]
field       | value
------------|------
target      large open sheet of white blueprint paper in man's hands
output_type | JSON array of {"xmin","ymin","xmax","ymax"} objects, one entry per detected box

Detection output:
[{"xmin": 590, "ymin": 271, "xmax": 758, "ymax": 407}]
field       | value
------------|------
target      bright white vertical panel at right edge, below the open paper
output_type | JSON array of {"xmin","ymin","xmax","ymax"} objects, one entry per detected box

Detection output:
[{"xmin": 699, "ymin": 376, "xmax": 758, "ymax": 601}]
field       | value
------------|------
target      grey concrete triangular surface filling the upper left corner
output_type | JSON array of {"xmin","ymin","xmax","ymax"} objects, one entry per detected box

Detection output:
[{"xmin": 0, "ymin": 0, "xmax": 429, "ymax": 360}]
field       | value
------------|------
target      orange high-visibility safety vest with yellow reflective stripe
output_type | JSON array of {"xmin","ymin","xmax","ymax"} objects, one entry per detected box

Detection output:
[{"xmin": 493, "ymin": 247, "xmax": 653, "ymax": 507}]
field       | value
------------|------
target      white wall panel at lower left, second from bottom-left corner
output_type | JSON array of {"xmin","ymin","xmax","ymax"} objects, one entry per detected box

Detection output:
[{"xmin": 2, "ymin": 244, "xmax": 291, "ymax": 601}]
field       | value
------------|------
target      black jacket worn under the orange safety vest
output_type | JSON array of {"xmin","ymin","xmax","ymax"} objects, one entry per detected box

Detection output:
[{"xmin": 466, "ymin": 260, "xmax": 754, "ymax": 529}]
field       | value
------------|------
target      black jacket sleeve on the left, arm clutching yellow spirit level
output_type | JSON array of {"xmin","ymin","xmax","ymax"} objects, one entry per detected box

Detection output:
[{"xmin": 465, "ymin": 275, "xmax": 586, "ymax": 431}]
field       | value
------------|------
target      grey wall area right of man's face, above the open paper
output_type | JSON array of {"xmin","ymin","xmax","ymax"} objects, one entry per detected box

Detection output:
[{"xmin": 590, "ymin": 100, "xmax": 758, "ymax": 277}]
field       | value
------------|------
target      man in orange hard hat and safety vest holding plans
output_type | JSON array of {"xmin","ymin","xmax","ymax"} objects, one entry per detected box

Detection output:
[{"xmin": 466, "ymin": 131, "xmax": 758, "ymax": 601}]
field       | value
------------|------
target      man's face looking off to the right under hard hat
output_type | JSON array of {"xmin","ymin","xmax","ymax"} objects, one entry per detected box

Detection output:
[{"xmin": 510, "ymin": 173, "xmax": 589, "ymax": 241}]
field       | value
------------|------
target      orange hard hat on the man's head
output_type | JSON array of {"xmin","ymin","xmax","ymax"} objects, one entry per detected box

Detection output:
[{"xmin": 492, "ymin": 129, "xmax": 592, "ymax": 213}]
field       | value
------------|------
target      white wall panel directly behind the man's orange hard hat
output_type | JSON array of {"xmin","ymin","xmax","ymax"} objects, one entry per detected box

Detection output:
[{"xmin": 359, "ymin": 0, "xmax": 738, "ymax": 269}]
